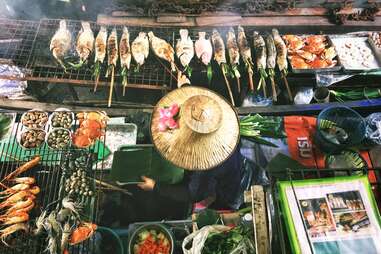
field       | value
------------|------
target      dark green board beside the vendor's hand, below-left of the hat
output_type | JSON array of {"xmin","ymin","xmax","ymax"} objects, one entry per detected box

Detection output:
[{"xmin": 110, "ymin": 145, "xmax": 184, "ymax": 184}]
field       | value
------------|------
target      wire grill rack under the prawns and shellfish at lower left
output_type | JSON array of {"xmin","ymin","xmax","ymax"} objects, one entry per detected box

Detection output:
[{"xmin": 0, "ymin": 114, "xmax": 107, "ymax": 254}]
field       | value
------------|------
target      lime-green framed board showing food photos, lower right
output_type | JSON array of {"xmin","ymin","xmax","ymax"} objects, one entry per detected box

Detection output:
[{"xmin": 278, "ymin": 176, "xmax": 381, "ymax": 254}]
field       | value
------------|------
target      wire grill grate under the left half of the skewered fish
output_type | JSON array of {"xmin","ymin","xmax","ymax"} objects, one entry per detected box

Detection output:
[{"xmin": 31, "ymin": 19, "xmax": 174, "ymax": 89}]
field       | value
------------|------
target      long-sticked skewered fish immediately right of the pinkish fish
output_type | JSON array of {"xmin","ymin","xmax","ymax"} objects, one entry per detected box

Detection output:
[{"xmin": 212, "ymin": 29, "xmax": 234, "ymax": 106}]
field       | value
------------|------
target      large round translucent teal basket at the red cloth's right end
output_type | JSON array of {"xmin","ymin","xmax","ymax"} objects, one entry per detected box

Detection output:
[{"xmin": 315, "ymin": 106, "xmax": 365, "ymax": 153}]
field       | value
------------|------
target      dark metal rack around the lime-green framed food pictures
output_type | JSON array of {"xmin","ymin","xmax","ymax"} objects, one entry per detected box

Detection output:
[{"xmin": 267, "ymin": 168, "xmax": 381, "ymax": 254}]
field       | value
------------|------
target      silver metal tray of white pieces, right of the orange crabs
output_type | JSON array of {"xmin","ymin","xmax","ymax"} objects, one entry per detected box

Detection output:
[{"xmin": 329, "ymin": 35, "xmax": 381, "ymax": 73}]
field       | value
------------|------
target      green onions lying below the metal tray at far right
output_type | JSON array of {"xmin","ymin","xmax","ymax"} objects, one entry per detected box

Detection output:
[{"xmin": 329, "ymin": 87, "xmax": 381, "ymax": 102}]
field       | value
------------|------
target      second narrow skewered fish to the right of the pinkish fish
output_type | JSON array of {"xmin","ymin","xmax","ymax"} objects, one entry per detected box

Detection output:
[{"xmin": 226, "ymin": 27, "xmax": 241, "ymax": 93}]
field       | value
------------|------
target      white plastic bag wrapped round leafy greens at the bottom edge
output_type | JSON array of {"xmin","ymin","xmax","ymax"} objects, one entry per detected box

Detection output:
[{"xmin": 182, "ymin": 225, "xmax": 230, "ymax": 254}]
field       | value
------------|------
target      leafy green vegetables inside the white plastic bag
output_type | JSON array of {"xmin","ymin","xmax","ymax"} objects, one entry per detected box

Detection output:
[{"xmin": 202, "ymin": 226, "xmax": 255, "ymax": 254}]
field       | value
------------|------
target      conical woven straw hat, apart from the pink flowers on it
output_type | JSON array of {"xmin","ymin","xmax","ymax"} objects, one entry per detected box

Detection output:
[{"xmin": 151, "ymin": 86, "xmax": 239, "ymax": 170}]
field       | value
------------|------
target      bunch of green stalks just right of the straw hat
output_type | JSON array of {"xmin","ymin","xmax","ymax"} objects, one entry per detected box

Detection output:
[{"xmin": 239, "ymin": 114, "xmax": 286, "ymax": 147}]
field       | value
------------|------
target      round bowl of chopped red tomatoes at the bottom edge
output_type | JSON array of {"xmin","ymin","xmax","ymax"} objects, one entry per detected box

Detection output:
[{"xmin": 128, "ymin": 224, "xmax": 174, "ymax": 254}]
